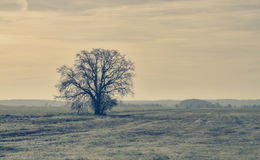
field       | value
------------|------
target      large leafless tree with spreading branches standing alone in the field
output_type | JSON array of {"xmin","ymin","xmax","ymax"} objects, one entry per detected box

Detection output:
[{"xmin": 57, "ymin": 49, "xmax": 135, "ymax": 115}]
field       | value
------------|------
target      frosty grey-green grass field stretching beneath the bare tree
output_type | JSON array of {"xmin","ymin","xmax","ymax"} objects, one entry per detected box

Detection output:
[{"xmin": 0, "ymin": 107, "xmax": 260, "ymax": 160}]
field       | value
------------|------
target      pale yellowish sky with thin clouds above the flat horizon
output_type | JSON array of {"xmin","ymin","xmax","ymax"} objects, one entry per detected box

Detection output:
[{"xmin": 0, "ymin": 0, "xmax": 260, "ymax": 99}]
